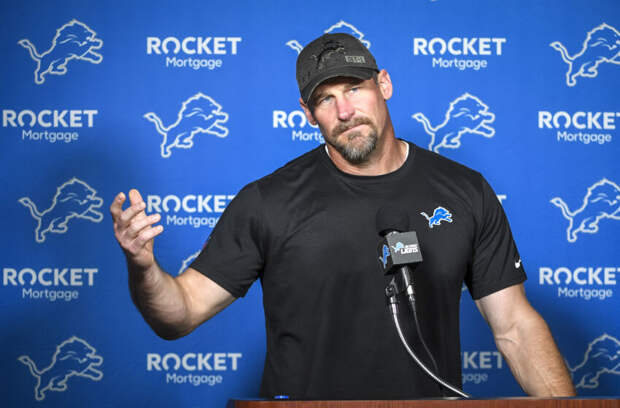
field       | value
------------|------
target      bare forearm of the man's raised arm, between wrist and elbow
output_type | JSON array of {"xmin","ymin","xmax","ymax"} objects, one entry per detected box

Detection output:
[{"xmin": 127, "ymin": 262, "xmax": 193, "ymax": 340}]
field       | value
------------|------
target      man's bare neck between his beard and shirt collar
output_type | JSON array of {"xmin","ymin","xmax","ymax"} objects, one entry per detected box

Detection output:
[{"xmin": 326, "ymin": 127, "xmax": 409, "ymax": 176}]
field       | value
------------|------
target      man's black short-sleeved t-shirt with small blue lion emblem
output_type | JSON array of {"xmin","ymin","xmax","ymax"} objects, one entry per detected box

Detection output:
[{"xmin": 191, "ymin": 143, "xmax": 525, "ymax": 399}]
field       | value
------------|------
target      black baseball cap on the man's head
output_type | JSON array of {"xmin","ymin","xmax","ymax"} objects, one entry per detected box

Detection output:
[{"xmin": 297, "ymin": 33, "xmax": 379, "ymax": 103}]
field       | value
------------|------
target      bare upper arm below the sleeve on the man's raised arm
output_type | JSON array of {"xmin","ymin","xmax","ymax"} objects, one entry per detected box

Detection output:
[{"xmin": 176, "ymin": 268, "xmax": 236, "ymax": 327}]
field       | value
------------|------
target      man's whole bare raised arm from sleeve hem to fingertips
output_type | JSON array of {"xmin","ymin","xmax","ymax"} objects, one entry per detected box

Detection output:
[{"xmin": 110, "ymin": 189, "xmax": 235, "ymax": 340}]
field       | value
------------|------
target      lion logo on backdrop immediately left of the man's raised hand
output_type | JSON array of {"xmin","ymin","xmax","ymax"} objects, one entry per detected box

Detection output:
[{"xmin": 18, "ymin": 177, "xmax": 103, "ymax": 243}]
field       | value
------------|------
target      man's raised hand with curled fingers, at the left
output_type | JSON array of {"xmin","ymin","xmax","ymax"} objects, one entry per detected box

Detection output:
[{"xmin": 110, "ymin": 189, "xmax": 164, "ymax": 270}]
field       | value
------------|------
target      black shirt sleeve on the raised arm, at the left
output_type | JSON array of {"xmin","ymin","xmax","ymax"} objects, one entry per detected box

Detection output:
[{"xmin": 190, "ymin": 183, "xmax": 264, "ymax": 297}]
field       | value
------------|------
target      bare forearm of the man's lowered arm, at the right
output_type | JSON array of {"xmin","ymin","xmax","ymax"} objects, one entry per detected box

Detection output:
[{"xmin": 495, "ymin": 309, "xmax": 575, "ymax": 397}]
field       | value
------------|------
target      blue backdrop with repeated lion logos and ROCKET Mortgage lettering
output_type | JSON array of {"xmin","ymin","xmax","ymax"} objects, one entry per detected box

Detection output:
[{"xmin": 0, "ymin": 0, "xmax": 620, "ymax": 407}]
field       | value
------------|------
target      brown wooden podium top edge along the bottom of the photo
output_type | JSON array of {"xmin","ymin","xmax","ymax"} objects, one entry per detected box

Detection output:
[{"xmin": 227, "ymin": 397, "xmax": 620, "ymax": 408}]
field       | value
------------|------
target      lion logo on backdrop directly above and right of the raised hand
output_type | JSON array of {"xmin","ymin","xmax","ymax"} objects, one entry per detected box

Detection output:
[{"xmin": 144, "ymin": 92, "xmax": 228, "ymax": 158}]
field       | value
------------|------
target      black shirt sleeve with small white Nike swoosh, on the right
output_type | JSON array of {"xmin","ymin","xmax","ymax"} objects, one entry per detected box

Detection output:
[{"xmin": 465, "ymin": 177, "xmax": 527, "ymax": 300}]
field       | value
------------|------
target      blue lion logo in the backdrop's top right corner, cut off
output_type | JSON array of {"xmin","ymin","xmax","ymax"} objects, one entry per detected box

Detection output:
[{"xmin": 549, "ymin": 23, "xmax": 620, "ymax": 86}]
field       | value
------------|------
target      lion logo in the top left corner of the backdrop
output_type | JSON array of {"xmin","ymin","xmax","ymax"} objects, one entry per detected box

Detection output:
[{"xmin": 17, "ymin": 19, "xmax": 103, "ymax": 85}]
